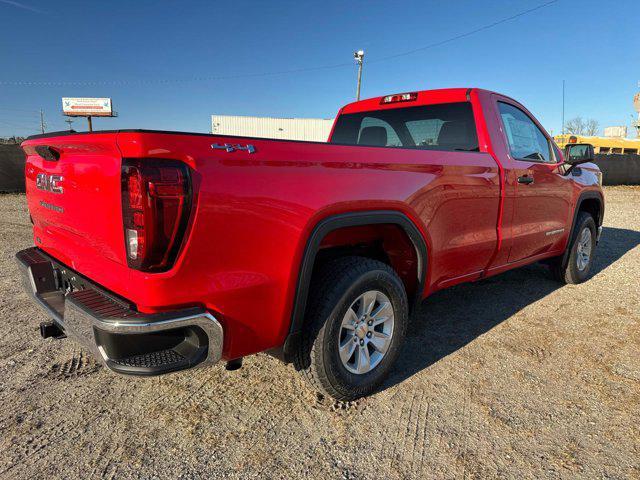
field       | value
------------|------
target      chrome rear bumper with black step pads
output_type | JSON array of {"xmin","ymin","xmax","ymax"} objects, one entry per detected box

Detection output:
[{"xmin": 16, "ymin": 248, "xmax": 224, "ymax": 375}]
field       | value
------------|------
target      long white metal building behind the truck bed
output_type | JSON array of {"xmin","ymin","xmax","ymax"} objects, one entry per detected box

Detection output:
[{"xmin": 211, "ymin": 115, "xmax": 333, "ymax": 142}]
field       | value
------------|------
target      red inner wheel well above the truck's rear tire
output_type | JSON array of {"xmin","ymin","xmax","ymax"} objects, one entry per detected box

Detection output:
[{"xmin": 313, "ymin": 224, "xmax": 420, "ymax": 303}]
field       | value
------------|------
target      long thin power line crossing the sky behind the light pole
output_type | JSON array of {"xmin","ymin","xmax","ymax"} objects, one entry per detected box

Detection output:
[{"xmin": 0, "ymin": 0, "xmax": 559, "ymax": 87}]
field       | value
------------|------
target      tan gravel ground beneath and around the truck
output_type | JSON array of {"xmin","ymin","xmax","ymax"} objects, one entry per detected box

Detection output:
[{"xmin": 0, "ymin": 187, "xmax": 640, "ymax": 479}]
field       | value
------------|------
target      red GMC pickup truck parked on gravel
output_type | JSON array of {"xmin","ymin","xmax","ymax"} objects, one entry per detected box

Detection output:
[{"xmin": 17, "ymin": 88, "xmax": 604, "ymax": 400}]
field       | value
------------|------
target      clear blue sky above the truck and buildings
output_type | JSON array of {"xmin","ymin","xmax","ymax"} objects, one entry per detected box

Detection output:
[{"xmin": 0, "ymin": 0, "xmax": 640, "ymax": 136}]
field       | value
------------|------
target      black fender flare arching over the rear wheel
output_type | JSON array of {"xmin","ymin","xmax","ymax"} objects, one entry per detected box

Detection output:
[{"xmin": 282, "ymin": 210, "xmax": 427, "ymax": 361}]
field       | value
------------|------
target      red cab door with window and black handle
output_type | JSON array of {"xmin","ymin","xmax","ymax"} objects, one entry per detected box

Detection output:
[{"xmin": 498, "ymin": 101, "xmax": 572, "ymax": 262}]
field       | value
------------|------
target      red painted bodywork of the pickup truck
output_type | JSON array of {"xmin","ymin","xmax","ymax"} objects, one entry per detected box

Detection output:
[{"xmin": 18, "ymin": 89, "xmax": 600, "ymax": 358}]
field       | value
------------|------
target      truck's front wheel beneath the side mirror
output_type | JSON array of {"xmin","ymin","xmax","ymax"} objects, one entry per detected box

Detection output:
[{"xmin": 550, "ymin": 212, "xmax": 596, "ymax": 284}]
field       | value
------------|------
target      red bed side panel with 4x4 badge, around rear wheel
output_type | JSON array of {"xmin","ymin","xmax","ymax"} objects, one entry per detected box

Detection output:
[{"xmin": 118, "ymin": 132, "xmax": 499, "ymax": 357}]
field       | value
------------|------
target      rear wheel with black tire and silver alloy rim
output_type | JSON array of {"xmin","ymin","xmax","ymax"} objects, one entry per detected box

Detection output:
[{"xmin": 294, "ymin": 257, "xmax": 409, "ymax": 401}]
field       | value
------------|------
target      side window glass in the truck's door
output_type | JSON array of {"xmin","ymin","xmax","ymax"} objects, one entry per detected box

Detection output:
[{"xmin": 498, "ymin": 102, "xmax": 555, "ymax": 163}]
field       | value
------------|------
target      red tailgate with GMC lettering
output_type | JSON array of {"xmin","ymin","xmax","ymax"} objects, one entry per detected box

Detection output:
[{"xmin": 23, "ymin": 133, "xmax": 128, "ymax": 287}]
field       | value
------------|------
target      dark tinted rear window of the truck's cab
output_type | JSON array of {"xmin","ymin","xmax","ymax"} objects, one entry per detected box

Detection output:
[{"xmin": 331, "ymin": 102, "xmax": 479, "ymax": 152}]
